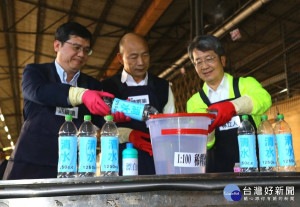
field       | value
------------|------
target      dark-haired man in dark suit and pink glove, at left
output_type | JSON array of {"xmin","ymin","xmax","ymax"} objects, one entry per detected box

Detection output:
[{"xmin": 4, "ymin": 22, "xmax": 114, "ymax": 180}]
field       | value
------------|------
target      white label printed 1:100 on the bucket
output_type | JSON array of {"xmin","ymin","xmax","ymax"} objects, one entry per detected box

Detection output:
[{"xmin": 174, "ymin": 152, "xmax": 206, "ymax": 167}]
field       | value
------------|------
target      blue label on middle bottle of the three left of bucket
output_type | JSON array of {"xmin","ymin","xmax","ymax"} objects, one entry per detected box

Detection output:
[{"xmin": 78, "ymin": 137, "xmax": 97, "ymax": 173}]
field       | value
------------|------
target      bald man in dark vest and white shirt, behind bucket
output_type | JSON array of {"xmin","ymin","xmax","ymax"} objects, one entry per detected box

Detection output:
[{"xmin": 103, "ymin": 33, "xmax": 175, "ymax": 175}]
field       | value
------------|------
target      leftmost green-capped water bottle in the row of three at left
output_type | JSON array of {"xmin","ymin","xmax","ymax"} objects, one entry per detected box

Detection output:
[{"xmin": 57, "ymin": 115, "xmax": 77, "ymax": 178}]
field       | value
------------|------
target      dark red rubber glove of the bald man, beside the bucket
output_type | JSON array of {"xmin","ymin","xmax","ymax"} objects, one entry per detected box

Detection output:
[{"xmin": 129, "ymin": 130, "xmax": 153, "ymax": 156}]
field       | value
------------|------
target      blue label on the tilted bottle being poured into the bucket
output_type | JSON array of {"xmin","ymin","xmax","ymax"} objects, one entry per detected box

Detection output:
[{"xmin": 111, "ymin": 98, "xmax": 145, "ymax": 121}]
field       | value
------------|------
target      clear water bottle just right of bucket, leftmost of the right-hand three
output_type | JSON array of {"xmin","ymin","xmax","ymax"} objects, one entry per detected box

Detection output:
[{"xmin": 238, "ymin": 115, "xmax": 258, "ymax": 172}]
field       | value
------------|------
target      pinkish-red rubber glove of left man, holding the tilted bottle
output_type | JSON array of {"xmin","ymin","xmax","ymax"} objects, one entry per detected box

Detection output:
[{"xmin": 82, "ymin": 90, "xmax": 115, "ymax": 116}]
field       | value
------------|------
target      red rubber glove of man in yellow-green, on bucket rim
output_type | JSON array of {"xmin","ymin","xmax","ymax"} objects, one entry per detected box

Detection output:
[{"xmin": 207, "ymin": 101, "xmax": 236, "ymax": 133}]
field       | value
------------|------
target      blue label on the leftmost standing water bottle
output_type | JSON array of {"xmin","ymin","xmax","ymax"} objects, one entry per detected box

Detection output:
[{"xmin": 57, "ymin": 136, "xmax": 77, "ymax": 173}]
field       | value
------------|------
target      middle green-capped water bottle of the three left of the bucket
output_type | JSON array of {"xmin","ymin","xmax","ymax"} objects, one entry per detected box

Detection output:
[{"xmin": 78, "ymin": 115, "xmax": 97, "ymax": 177}]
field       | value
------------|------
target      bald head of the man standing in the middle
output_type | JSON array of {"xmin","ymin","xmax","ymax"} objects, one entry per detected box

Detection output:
[{"xmin": 117, "ymin": 33, "xmax": 150, "ymax": 83}]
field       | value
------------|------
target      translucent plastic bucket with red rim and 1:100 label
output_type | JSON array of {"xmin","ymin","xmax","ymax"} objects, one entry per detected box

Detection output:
[{"xmin": 146, "ymin": 113, "xmax": 215, "ymax": 175}]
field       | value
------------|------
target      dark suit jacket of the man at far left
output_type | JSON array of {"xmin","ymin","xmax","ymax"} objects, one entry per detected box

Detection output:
[{"xmin": 10, "ymin": 62, "xmax": 104, "ymax": 168}]
